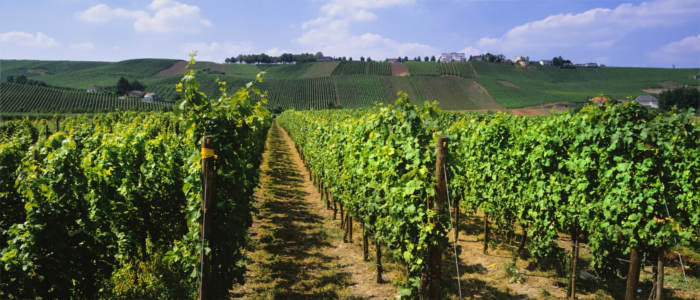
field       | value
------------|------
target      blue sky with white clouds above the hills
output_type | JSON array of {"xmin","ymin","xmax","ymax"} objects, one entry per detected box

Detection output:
[{"xmin": 0, "ymin": 0, "xmax": 700, "ymax": 67}]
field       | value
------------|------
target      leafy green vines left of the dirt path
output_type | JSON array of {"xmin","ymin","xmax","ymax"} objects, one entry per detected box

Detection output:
[{"xmin": 0, "ymin": 55, "xmax": 270, "ymax": 299}]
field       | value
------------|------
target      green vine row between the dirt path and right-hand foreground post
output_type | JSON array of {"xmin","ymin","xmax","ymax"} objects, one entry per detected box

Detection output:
[{"xmin": 278, "ymin": 94, "xmax": 447, "ymax": 295}]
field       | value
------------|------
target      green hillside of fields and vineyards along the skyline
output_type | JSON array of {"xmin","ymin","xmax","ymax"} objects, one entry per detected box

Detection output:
[{"xmin": 0, "ymin": 59, "xmax": 699, "ymax": 110}]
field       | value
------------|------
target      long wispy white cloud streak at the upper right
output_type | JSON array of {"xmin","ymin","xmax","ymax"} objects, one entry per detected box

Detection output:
[{"xmin": 464, "ymin": 0, "xmax": 700, "ymax": 55}]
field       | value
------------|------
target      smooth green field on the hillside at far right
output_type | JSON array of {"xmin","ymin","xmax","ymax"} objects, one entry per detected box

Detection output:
[{"xmin": 473, "ymin": 63, "xmax": 698, "ymax": 108}]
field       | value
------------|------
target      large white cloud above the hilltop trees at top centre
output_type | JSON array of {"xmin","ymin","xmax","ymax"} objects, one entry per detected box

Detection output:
[{"xmin": 296, "ymin": 0, "xmax": 437, "ymax": 59}]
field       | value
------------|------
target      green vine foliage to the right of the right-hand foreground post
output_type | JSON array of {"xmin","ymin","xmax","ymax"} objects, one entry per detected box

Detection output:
[{"xmin": 447, "ymin": 103, "xmax": 700, "ymax": 275}]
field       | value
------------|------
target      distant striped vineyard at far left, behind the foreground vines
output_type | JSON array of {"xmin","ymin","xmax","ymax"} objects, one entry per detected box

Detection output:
[{"xmin": 0, "ymin": 83, "xmax": 171, "ymax": 113}]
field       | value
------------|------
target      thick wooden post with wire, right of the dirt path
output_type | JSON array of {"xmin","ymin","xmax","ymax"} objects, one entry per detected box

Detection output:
[{"xmin": 428, "ymin": 135, "xmax": 448, "ymax": 300}]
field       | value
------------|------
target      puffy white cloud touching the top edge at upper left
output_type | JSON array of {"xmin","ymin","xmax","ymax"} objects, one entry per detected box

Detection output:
[{"xmin": 77, "ymin": 0, "xmax": 212, "ymax": 32}]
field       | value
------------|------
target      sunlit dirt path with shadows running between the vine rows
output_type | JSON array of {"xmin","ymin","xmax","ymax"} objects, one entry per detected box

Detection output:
[{"xmin": 232, "ymin": 123, "xmax": 396, "ymax": 299}]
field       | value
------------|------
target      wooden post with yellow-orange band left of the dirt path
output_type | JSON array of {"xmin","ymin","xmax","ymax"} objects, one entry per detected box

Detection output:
[{"xmin": 199, "ymin": 136, "xmax": 216, "ymax": 300}]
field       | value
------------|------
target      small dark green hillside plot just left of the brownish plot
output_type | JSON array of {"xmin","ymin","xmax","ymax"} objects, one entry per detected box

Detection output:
[{"xmin": 333, "ymin": 75, "xmax": 386, "ymax": 108}]
